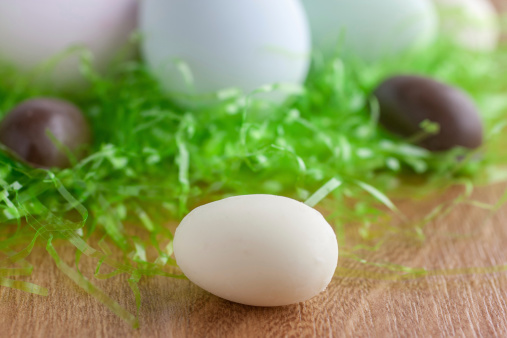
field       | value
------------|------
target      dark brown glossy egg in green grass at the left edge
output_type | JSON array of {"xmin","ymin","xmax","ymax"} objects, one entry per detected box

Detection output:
[{"xmin": 0, "ymin": 98, "xmax": 91, "ymax": 168}]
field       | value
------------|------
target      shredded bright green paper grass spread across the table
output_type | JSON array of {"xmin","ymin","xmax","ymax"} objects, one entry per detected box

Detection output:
[{"xmin": 0, "ymin": 41, "xmax": 507, "ymax": 326}]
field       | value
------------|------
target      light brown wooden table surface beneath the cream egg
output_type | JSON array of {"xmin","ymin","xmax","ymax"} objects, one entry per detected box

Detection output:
[{"xmin": 0, "ymin": 185, "xmax": 507, "ymax": 337}]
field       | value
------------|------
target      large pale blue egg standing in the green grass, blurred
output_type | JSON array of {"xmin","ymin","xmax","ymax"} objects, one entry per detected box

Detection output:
[{"xmin": 140, "ymin": 0, "xmax": 311, "ymax": 103}]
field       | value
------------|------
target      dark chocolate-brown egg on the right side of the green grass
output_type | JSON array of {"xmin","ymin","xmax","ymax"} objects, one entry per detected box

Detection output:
[{"xmin": 374, "ymin": 76, "xmax": 483, "ymax": 151}]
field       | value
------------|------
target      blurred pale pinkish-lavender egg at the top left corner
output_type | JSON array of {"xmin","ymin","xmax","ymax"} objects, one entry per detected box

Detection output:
[{"xmin": 0, "ymin": 0, "xmax": 138, "ymax": 85}]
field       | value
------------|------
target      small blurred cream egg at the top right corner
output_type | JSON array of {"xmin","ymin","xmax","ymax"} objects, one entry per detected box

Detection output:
[{"xmin": 434, "ymin": 0, "xmax": 500, "ymax": 51}]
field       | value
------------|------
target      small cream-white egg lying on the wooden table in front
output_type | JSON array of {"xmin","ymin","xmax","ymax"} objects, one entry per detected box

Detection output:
[{"xmin": 174, "ymin": 195, "xmax": 338, "ymax": 306}]
